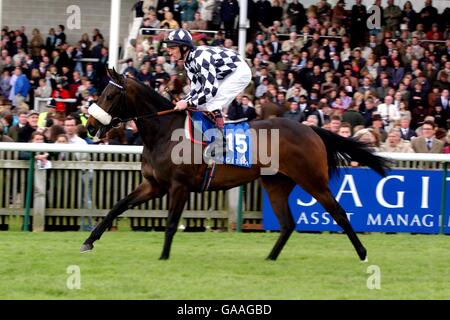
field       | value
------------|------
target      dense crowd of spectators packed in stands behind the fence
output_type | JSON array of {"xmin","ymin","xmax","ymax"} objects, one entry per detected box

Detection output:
[{"xmin": 0, "ymin": 0, "xmax": 450, "ymax": 159}]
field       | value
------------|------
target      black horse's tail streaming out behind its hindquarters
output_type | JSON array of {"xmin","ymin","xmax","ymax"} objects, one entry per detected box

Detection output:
[{"xmin": 311, "ymin": 126, "xmax": 391, "ymax": 177}]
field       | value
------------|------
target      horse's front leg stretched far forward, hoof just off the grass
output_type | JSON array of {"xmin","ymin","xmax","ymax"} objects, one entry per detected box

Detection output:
[{"xmin": 80, "ymin": 179, "xmax": 166, "ymax": 252}]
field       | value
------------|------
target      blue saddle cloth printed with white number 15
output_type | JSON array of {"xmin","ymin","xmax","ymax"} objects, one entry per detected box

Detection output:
[{"xmin": 190, "ymin": 112, "xmax": 252, "ymax": 168}]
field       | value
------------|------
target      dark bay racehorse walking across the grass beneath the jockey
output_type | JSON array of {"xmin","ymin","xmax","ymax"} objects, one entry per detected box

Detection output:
[{"xmin": 81, "ymin": 69, "xmax": 388, "ymax": 261}]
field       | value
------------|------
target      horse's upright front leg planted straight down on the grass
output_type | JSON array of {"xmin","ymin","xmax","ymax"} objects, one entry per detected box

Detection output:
[{"xmin": 159, "ymin": 184, "xmax": 189, "ymax": 260}]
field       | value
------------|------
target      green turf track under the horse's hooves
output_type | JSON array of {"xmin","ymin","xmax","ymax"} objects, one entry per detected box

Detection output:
[{"xmin": 0, "ymin": 231, "xmax": 450, "ymax": 300}]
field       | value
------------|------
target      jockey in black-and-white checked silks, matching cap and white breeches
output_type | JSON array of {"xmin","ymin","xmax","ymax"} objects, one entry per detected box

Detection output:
[{"xmin": 164, "ymin": 29, "xmax": 252, "ymax": 160}]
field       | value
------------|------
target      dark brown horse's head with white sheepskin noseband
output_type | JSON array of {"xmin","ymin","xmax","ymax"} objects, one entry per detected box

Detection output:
[{"xmin": 86, "ymin": 69, "xmax": 133, "ymax": 138}]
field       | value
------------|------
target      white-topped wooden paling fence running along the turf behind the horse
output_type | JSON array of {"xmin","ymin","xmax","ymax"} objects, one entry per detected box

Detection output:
[{"xmin": 0, "ymin": 143, "xmax": 450, "ymax": 231}]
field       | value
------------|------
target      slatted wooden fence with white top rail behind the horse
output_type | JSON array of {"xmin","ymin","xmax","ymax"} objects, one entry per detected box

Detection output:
[{"xmin": 0, "ymin": 143, "xmax": 450, "ymax": 231}]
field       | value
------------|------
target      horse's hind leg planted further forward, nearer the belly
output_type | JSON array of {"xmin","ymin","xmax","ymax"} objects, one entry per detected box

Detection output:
[{"xmin": 261, "ymin": 173, "xmax": 295, "ymax": 260}]
